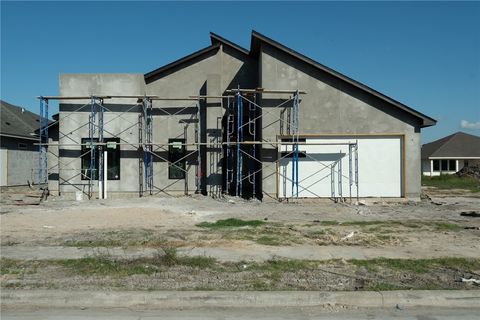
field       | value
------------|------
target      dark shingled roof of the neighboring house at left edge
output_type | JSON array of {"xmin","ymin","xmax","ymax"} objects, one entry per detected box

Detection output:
[{"xmin": 0, "ymin": 100, "xmax": 40, "ymax": 140}]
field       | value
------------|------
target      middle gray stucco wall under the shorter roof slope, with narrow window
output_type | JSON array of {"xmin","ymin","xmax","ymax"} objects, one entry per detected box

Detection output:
[{"xmin": 147, "ymin": 46, "xmax": 256, "ymax": 196}]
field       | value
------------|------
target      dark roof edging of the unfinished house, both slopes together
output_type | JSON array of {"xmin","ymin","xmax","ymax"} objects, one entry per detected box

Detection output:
[{"xmin": 145, "ymin": 30, "xmax": 437, "ymax": 128}]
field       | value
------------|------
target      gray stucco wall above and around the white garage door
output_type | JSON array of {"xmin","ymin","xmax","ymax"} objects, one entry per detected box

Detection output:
[{"xmin": 259, "ymin": 45, "xmax": 420, "ymax": 197}]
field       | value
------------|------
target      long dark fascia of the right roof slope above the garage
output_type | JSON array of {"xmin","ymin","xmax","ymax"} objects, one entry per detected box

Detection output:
[{"xmin": 250, "ymin": 30, "xmax": 437, "ymax": 128}]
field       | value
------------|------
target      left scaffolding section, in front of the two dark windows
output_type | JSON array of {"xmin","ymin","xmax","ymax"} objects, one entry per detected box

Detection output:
[{"xmin": 38, "ymin": 95, "xmax": 200, "ymax": 199}]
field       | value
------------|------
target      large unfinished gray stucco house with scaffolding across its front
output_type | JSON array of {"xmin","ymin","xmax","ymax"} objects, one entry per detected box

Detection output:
[{"xmin": 44, "ymin": 31, "xmax": 436, "ymax": 199}]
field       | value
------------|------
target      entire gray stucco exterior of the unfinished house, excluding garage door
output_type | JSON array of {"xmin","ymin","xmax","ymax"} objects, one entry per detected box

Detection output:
[{"xmin": 50, "ymin": 31, "xmax": 434, "ymax": 198}]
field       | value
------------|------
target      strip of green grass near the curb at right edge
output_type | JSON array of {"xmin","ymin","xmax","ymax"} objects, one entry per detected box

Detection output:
[{"xmin": 348, "ymin": 258, "xmax": 480, "ymax": 273}]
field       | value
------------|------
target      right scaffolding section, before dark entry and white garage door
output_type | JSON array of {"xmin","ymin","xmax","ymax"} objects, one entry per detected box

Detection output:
[{"xmin": 219, "ymin": 87, "xmax": 359, "ymax": 201}]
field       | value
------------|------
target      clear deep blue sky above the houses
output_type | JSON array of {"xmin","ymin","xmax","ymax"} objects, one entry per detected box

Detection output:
[{"xmin": 1, "ymin": 1, "xmax": 480, "ymax": 142}]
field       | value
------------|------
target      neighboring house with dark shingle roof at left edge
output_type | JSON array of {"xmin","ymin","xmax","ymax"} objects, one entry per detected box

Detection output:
[{"xmin": 0, "ymin": 100, "xmax": 39, "ymax": 186}]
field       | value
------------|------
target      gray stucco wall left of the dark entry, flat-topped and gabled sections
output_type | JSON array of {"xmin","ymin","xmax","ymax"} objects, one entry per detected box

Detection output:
[{"xmin": 56, "ymin": 46, "xmax": 256, "ymax": 195}]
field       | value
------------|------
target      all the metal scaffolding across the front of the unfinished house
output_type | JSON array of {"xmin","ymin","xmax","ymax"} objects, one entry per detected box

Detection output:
[{"xmin": 38, "ymin": 86, "xmax": 359, "ymax": 201}]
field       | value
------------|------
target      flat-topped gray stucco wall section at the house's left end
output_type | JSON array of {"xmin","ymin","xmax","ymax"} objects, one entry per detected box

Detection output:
[{"xmin": 58, "ymin": 74, "xmax": 145, "ymax": 193}]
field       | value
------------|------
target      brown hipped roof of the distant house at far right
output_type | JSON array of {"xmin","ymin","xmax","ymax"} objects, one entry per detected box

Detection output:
[{"xmin": 422, "ymin": 132, "xmax": 480, "ymax": 159}]
